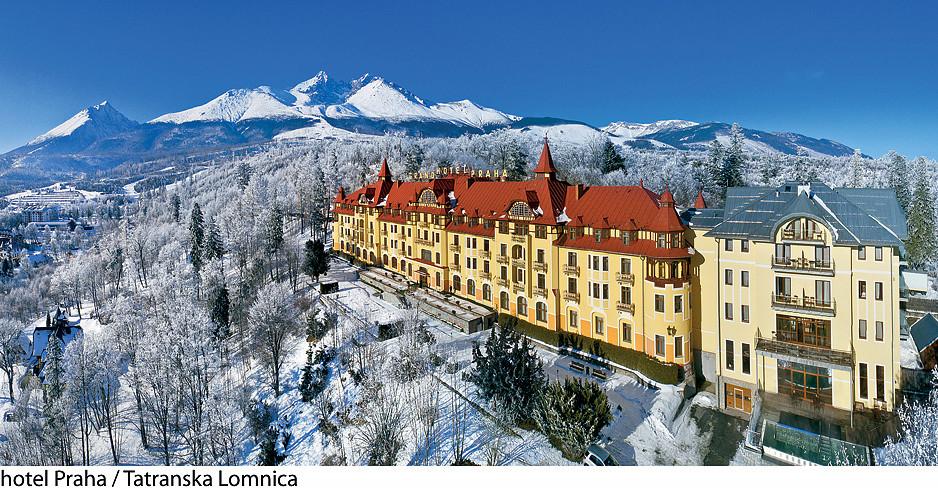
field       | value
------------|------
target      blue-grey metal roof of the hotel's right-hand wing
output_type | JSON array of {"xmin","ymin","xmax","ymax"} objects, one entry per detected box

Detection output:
[{"xmin": 706, "ymin": 182, "xmax": 908, "ymax": 248}]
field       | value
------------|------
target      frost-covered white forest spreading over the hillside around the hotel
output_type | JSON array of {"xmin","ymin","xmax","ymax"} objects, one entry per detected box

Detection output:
[{"xmin": 0, "ymin": 132, "xmax": 938, "ymax": 465}]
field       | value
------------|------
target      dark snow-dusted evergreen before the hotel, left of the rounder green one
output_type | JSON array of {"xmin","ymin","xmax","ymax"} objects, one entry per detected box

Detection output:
[{"xmin": 468, "ymin": 323, "xmax": 546, "ymax": 422}]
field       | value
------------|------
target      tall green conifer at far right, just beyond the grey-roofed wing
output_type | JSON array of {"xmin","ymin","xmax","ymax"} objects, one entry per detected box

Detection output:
[{"xmin": 906, "ymin": 158, "xmax": 938, "ymax": 268}]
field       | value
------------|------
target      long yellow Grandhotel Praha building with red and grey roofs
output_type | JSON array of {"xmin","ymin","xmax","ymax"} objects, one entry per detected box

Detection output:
[{"xmin": 333, "ymin": 141, "xmax": 906, "ymax": 436}]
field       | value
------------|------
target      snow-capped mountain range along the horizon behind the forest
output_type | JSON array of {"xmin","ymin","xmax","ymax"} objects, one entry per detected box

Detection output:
[{"xmin": 0, "ymin": 72, "xmax": 853, "ymax": 191}]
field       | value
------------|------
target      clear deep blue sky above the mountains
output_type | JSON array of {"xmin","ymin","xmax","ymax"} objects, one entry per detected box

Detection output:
[{"xmin": 0, "ymin": 0, "xmax": 938, "ymax": 157}]
